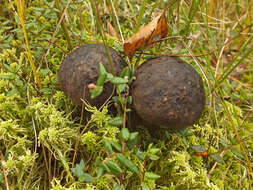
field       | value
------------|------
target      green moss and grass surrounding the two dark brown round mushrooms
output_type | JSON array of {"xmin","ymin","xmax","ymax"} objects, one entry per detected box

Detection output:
[{"xmin": 0, "ymin": 0, "xmax": 253, "ymax": 190}]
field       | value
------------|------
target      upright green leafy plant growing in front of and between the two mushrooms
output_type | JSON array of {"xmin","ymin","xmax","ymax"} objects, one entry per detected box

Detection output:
[{"xmin": 71, "ymin": 64, "xmax": 164, "ymax": 190}]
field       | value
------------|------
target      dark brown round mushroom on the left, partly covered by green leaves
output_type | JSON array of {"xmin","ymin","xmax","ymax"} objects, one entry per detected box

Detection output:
[{"xmin": 58, "ymin": 44, "xmax": 127, "ymax": 107}]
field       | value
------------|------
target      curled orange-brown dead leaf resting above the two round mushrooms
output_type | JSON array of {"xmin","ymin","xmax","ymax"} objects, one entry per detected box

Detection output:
[{"xmin": 124, "ymin": 13, "xmax": 168, "ymax": 58}]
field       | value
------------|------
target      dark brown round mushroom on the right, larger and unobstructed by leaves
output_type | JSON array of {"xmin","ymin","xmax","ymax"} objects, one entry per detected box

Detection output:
[{"xmin": 131, "ymin": 56, "xmax": 205, "ymax": 130}]
